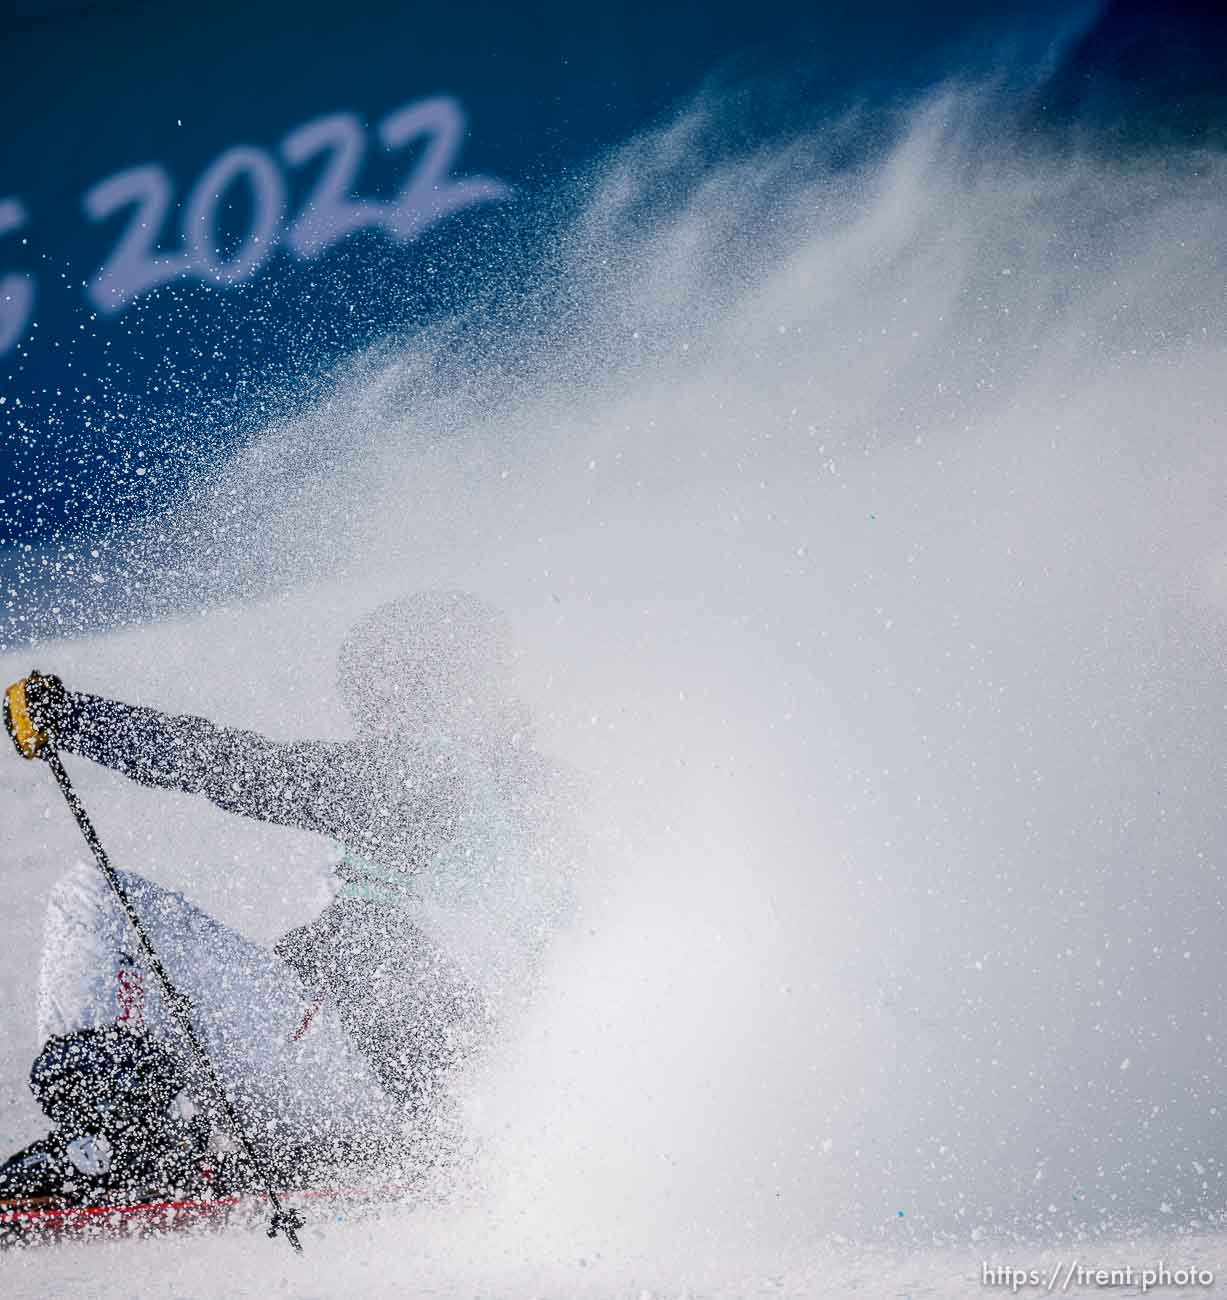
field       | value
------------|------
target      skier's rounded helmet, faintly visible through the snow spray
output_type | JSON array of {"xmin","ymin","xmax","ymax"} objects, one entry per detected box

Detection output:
[{"xmin": 337, "ymin": 592, "xmax": 524, "ymax": 744}]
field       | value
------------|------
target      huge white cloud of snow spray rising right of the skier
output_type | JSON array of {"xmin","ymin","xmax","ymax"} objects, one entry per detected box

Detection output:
[{"xmin": 12, "ymin": 83, "xmax": 1227, "ymax": 1295}]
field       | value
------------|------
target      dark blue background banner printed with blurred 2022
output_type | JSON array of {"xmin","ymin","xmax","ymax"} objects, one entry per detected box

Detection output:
[{"xmin": 0, "ymin": 0, "xmax": 1216, "ymax": 553}]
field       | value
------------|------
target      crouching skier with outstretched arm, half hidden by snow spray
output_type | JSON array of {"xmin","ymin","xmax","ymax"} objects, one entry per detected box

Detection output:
[{"xmin": 0, "ymin": 592, "xmax": 576, "ymax": 1201}]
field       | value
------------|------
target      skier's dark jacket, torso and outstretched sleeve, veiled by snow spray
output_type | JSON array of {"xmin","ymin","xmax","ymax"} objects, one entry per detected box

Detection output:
[{"xmin": 56, "ymin": 692, "xmax": 578, "ymax": 987}]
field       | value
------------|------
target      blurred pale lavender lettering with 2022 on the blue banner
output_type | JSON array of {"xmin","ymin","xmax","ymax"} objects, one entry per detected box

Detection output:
[{"xmin": 0, "ymin": 95, "xmax": 511, "ymax": 355}]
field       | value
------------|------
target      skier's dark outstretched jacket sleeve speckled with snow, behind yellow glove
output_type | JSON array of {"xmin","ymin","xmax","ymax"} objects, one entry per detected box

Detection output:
[{"xmin": 56, "ymin": 692, "xmax": 369, "ymax": 840}]
